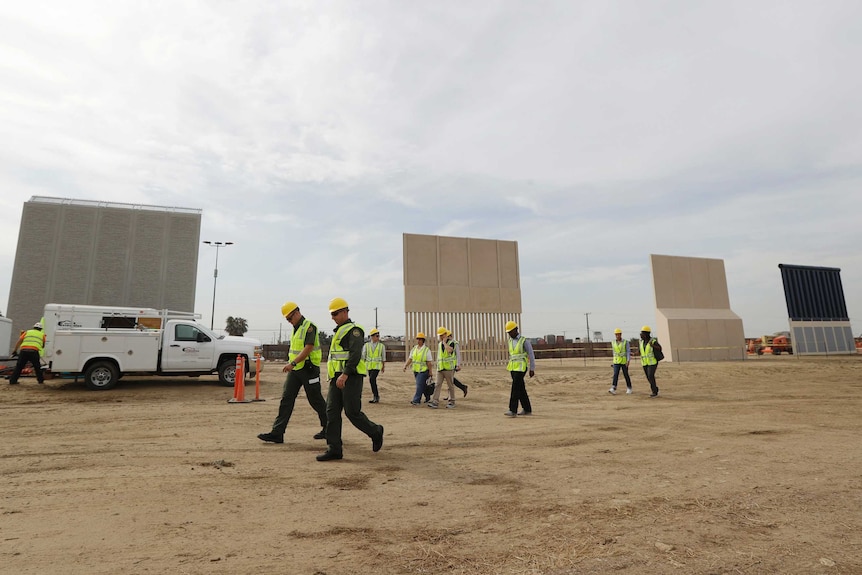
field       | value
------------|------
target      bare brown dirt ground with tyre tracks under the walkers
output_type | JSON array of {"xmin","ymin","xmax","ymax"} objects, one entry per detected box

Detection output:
[{"xmin": 0, "ymin": 356, "xmax": 862, "ymax": 575}]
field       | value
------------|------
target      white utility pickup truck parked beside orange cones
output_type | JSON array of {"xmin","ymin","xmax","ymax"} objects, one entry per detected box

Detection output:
[{"xmin": 44, "ymin": 304, "xmax": 261, "ymax": 390}]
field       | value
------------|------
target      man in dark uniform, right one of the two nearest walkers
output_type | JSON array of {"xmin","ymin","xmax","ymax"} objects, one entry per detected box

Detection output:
[{"xmin": 317, "ymin": 297, "xmax": 383, "ymax": 461}]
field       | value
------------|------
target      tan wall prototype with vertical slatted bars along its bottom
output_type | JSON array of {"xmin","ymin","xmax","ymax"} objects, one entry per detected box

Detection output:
[{"xmin": 403, "ymin": 234, "xmax": 521, "ymax": 365}]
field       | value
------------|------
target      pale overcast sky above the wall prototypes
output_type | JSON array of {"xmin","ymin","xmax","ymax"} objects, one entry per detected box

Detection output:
[{"xmin": 0, "ymin": 0, "xmax": 862, "ymax": 343}]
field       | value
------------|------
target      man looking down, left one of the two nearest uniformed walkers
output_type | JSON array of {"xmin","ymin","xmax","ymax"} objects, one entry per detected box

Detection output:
[{"xmin": 257, "ymin": 301, "xmax": 326, "ymax": 443}]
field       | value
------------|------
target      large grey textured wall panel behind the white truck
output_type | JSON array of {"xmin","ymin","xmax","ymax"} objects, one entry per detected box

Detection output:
[{"xmin": 7, "ymin": 196, "xmax": 201, "ymax": 352}]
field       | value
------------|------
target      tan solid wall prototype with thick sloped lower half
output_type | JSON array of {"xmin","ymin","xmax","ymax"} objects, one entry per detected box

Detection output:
[{"xmin": 650, "ymin": 254, "xmax": 745, "ymax": 361}]
